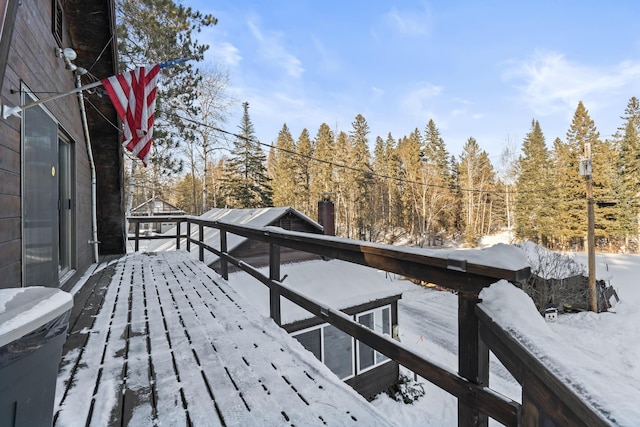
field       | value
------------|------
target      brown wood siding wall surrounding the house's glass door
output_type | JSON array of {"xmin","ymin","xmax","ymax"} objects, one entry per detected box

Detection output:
[{"xmin": 0, "ymin": 0, "xmax": 91, "ymax": 288}]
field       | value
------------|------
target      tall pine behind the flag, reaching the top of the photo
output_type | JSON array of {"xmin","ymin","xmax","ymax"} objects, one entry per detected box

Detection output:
[{"xmin": 116, "ymin": 0, "xmax": 217, "ymax": 211}]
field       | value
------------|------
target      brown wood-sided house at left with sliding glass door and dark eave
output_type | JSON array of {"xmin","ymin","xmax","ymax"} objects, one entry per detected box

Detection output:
[{"xmin": 0, "ymin": 0, "xmax": 125, "ymax": 288}]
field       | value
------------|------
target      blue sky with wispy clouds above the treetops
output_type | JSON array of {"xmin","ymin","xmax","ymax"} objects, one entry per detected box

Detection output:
[{"xmin": 183, "ymin": 0, "xmax": 640, "ymax": 166}]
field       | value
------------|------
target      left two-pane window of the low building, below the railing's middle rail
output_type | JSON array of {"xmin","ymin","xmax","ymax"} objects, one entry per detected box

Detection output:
[{"xmin": 291, "ymin": 324, "xmax": 353, "ymax": 380}]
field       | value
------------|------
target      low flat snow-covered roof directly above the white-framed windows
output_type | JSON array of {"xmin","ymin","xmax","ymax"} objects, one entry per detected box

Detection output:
[{"xmin": 228, "ymin": 260, "xmax": 401, "ymax": 325}]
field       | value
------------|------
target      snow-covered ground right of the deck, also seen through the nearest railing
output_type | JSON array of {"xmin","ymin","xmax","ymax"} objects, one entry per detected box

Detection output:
[{"xmin": 373, "ymin": 246, "xmax": 640, "ymax": 426}]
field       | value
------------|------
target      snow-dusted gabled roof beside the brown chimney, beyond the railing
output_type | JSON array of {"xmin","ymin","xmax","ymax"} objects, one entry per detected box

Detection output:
[{"xmin": 148, "ymin": 206, "xmax": 323, "ymax": 265}]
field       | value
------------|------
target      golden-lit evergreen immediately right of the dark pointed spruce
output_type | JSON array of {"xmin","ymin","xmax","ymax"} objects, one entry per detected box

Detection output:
[{"xmin": 270, "ymin": 124, "xmax": 298, "ymax": 206}]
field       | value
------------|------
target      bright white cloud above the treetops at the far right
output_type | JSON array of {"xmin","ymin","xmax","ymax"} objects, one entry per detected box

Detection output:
[{"xmin": 503, "ymin": 52, "xmax": 640, "ymax": 116}]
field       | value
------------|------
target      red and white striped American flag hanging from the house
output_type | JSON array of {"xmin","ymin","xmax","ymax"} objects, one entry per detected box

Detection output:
[{"xmin": 102, "ymin": 65, "xmax": 161, "ymax": 166}]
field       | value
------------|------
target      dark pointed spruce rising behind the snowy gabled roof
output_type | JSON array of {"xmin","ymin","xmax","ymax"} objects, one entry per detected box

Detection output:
[{"xmin": 225, "ymin": 102, "xmax": 273, "ymax": 208}]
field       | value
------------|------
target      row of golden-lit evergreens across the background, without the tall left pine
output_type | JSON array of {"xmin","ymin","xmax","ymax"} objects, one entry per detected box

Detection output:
[{"xmin": 156, "ymin": 97, "xmax": 640, "ymax": 251}]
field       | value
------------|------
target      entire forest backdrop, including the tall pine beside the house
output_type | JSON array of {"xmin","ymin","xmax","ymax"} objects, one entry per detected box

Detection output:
[{"xmin": 117, "ymin": 0, "xmax": 640, "ymax": 252}]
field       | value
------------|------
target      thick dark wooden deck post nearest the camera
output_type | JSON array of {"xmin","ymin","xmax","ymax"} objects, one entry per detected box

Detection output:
[{"xmin": 458, "ymin": 292, "xmax": 489, "ymax": 427}]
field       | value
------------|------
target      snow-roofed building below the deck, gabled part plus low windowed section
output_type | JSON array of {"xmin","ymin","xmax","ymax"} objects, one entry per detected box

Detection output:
[{"xmin": 149, "ymin": 207, "xmax": 401, "ymax": 398}]
